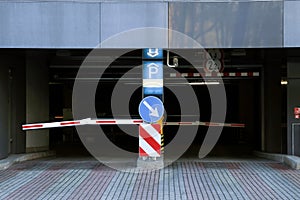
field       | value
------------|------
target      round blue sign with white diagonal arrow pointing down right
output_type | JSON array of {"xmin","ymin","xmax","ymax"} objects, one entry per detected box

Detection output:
[{"xmin": 139, "ymin": 96, "xmax": 165, "ymax": 123}]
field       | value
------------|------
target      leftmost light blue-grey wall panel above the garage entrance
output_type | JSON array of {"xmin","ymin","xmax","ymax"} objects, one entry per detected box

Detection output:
[{"xmin": 0, "ymin": 2, "xmax": 100, "ymax": 48}]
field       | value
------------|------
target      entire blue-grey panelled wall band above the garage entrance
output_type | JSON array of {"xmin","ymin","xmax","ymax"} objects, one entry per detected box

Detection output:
[{"xmin": 0, "ymin": 0, "xmax": 300, "ymax": 48}]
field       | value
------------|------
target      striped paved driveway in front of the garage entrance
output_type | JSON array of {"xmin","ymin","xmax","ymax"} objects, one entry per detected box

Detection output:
[{"xmin": 0, "ymin": 159, "xmax": 300, "ymax": 200}]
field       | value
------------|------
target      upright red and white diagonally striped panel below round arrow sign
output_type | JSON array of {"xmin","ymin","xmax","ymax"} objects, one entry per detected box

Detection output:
[{"xmin": 139, "ymin": 124, "xmax": 161, "ymax": 157}]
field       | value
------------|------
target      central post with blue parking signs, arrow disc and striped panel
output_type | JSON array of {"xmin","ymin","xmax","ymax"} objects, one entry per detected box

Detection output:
[{"xmin": 139, "ymin": 48, "xmax": 164, "ymax": 160}]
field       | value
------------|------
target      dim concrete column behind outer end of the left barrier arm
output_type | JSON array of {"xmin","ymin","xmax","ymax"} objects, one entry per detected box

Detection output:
[{"xmin": 26, "ymin": 51, "xmax": 49, "ymax": 152}]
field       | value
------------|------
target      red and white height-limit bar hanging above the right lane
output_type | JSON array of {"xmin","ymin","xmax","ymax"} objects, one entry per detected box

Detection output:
[{"xmin": 170, "ymin": 72, "xmax": 259, "ymax": 77}]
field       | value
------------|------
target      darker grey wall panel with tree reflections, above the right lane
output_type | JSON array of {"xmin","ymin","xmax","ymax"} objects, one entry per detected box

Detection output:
[{"xmin": 169, "ymin": 1, "xmax": 283, "ymax": 48}]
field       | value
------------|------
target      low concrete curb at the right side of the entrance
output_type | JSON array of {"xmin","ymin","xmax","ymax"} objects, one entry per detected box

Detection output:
[{"xmin": 253, "ymin": 151, "xmax": 300, "ymax": 169}]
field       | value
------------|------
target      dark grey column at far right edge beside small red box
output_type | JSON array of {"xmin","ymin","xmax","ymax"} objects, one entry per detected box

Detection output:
[{"xmin": 287, "ymin": 57, "xmax": 300, "ymax": 156}]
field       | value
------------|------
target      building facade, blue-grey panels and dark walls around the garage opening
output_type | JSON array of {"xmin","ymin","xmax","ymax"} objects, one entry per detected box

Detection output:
[{"xmin": 0, "ymin": 0, "xmax": 300, "ymax": 158}]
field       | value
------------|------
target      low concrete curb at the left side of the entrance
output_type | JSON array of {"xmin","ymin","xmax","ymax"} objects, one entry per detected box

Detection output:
[{"xmin": 0, "ymin": 151, "xmax": 56, "ymax": 170}]
